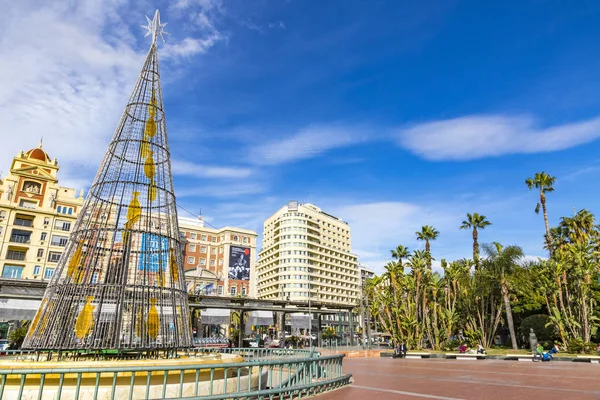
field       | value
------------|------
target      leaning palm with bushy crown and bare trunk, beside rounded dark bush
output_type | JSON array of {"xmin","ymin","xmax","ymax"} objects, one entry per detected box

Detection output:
[{"xmin": 483, "ymin": 242, "xmax": 524, "ymax": 350}]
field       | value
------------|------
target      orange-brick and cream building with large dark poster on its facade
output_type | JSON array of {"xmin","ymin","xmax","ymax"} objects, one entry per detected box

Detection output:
[{"xmin": 178, "ymin": 217, "xmax": 258, "ymax": 297}]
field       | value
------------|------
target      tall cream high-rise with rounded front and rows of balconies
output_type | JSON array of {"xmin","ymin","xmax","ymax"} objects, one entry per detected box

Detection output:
[{"xmin": 257, "ymin": 201, "xmax": 360, "ymax": 304}]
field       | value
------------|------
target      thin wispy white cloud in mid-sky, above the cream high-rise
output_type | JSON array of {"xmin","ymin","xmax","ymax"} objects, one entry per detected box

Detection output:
[{"xmin": 249, "ymin": 125, "xmax": 371, "ymax": 165}]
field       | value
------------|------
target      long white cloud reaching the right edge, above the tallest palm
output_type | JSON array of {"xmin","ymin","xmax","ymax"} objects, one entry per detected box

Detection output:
[{"xmin": 397, "ymin": 115, "xmax": 600, "ymax": 161}]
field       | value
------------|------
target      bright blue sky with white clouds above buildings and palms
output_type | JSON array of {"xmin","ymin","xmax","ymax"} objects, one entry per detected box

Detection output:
[{"xmin": 0, "ymin": 0, "xmax": 600, "ymax": 271}]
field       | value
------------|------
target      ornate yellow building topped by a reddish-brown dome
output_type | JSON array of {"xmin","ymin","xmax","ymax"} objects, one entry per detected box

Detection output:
[{"xmin": 0, "ymin": 143, "xmax": 84, "ymax": 280}]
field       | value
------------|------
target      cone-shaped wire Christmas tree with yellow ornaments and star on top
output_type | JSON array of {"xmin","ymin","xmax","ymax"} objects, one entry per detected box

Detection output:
[{"xmin": 23, "ymin": 10, "xmax": 192, "ymax": 350}]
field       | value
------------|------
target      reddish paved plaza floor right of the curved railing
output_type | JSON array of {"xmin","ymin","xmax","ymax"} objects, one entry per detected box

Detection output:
[{"xmin": 318, "ymin": 358, "xmax": 600, "ymax": 400}]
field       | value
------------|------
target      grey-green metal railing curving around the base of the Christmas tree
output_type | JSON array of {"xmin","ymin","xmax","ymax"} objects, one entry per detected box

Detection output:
[{"xmin": 0, "ymin": 348, "xmax": 351, "ymax": 400}]
